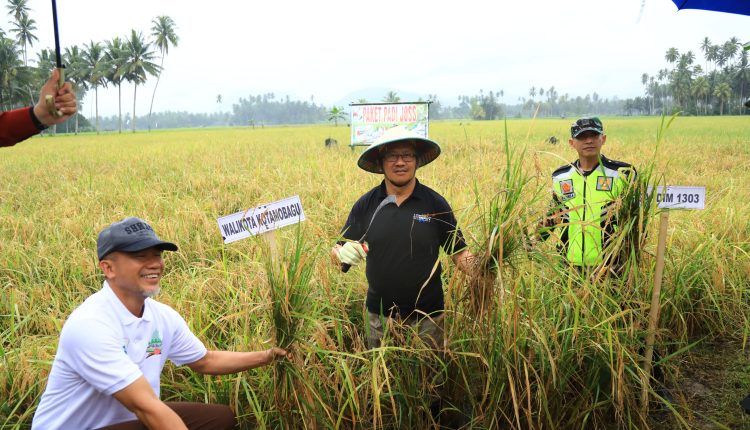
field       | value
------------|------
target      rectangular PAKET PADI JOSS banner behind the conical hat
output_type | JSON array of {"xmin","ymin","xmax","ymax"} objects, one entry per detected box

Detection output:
[{"xmin": 350, "ymin": 102, "xmax": 430, "ymax": 146}]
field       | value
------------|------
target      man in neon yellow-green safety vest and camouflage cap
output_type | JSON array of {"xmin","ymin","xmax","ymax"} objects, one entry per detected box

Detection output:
[{"xmin": 542, "ymin": 117, "xmax": 635, "ymax": 271}]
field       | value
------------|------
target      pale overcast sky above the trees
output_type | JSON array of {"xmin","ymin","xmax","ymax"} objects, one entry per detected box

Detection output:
[{"xmin": 13, "ymin": 0, "xmax": 750, "ymax": 116}]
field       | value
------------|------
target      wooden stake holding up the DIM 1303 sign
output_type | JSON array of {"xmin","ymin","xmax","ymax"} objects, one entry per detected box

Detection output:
[{"xmin": 641, "ymin": 209, "xmax": 669, "ymax": 419}]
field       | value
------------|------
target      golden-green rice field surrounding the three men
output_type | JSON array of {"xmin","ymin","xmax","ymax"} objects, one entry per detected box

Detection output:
[{"xmin": 0, "ymin": 117, "xmax": 750, "ymax": 429}]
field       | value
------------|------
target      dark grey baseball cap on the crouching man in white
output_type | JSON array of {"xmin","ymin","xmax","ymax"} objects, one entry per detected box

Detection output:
[{"xmin": 96, "ymin": 217, "xmax": 177, "ymax": 260}]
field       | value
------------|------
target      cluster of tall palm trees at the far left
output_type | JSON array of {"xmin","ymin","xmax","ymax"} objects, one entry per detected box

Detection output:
[{"xmin": 0, "ymin": 0, "xmax": 179, "ymax": 133}]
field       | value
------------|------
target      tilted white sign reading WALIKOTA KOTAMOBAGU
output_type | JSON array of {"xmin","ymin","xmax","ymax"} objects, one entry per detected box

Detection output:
[{"xmin": 218, "ymin": 196, "xmax": 305, "ymax": 243}]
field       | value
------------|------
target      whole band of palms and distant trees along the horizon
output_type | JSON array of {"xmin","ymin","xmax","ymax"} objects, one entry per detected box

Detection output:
[{"xmin": 0, "ymin": 0, "xmax": 750, "ymax": 133}]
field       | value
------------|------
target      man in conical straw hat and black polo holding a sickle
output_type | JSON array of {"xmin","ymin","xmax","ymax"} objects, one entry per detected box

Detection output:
[{"xmin": 333, "ymin": 126, "xmax": 472, "ymax": 348}]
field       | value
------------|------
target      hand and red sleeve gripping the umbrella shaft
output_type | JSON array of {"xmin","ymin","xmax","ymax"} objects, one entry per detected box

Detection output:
[{"xmin": 0, "ymin": 69, "xmax": 78, "ymax": 146}]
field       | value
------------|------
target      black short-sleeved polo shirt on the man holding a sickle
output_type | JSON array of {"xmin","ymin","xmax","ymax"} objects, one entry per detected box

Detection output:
[{"xmin": 342, "ymin": 181, "xmax": 466, "ymax": 318}]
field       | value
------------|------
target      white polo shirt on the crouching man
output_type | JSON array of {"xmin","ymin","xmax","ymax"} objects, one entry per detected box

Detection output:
[{"xmin": 31, "ymin": 281, "xmax": 207, "ymax": 430}]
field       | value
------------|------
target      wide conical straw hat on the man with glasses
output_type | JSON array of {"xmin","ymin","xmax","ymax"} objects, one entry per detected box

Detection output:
[{"xmin": 357, "ymin": 125, "xmax": 440, "ymax": 173}]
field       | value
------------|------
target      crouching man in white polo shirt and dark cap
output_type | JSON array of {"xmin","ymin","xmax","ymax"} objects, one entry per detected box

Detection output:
[{"xmin": 32, "ymin": 217, "xmax": 286, "ymax": 430}]
